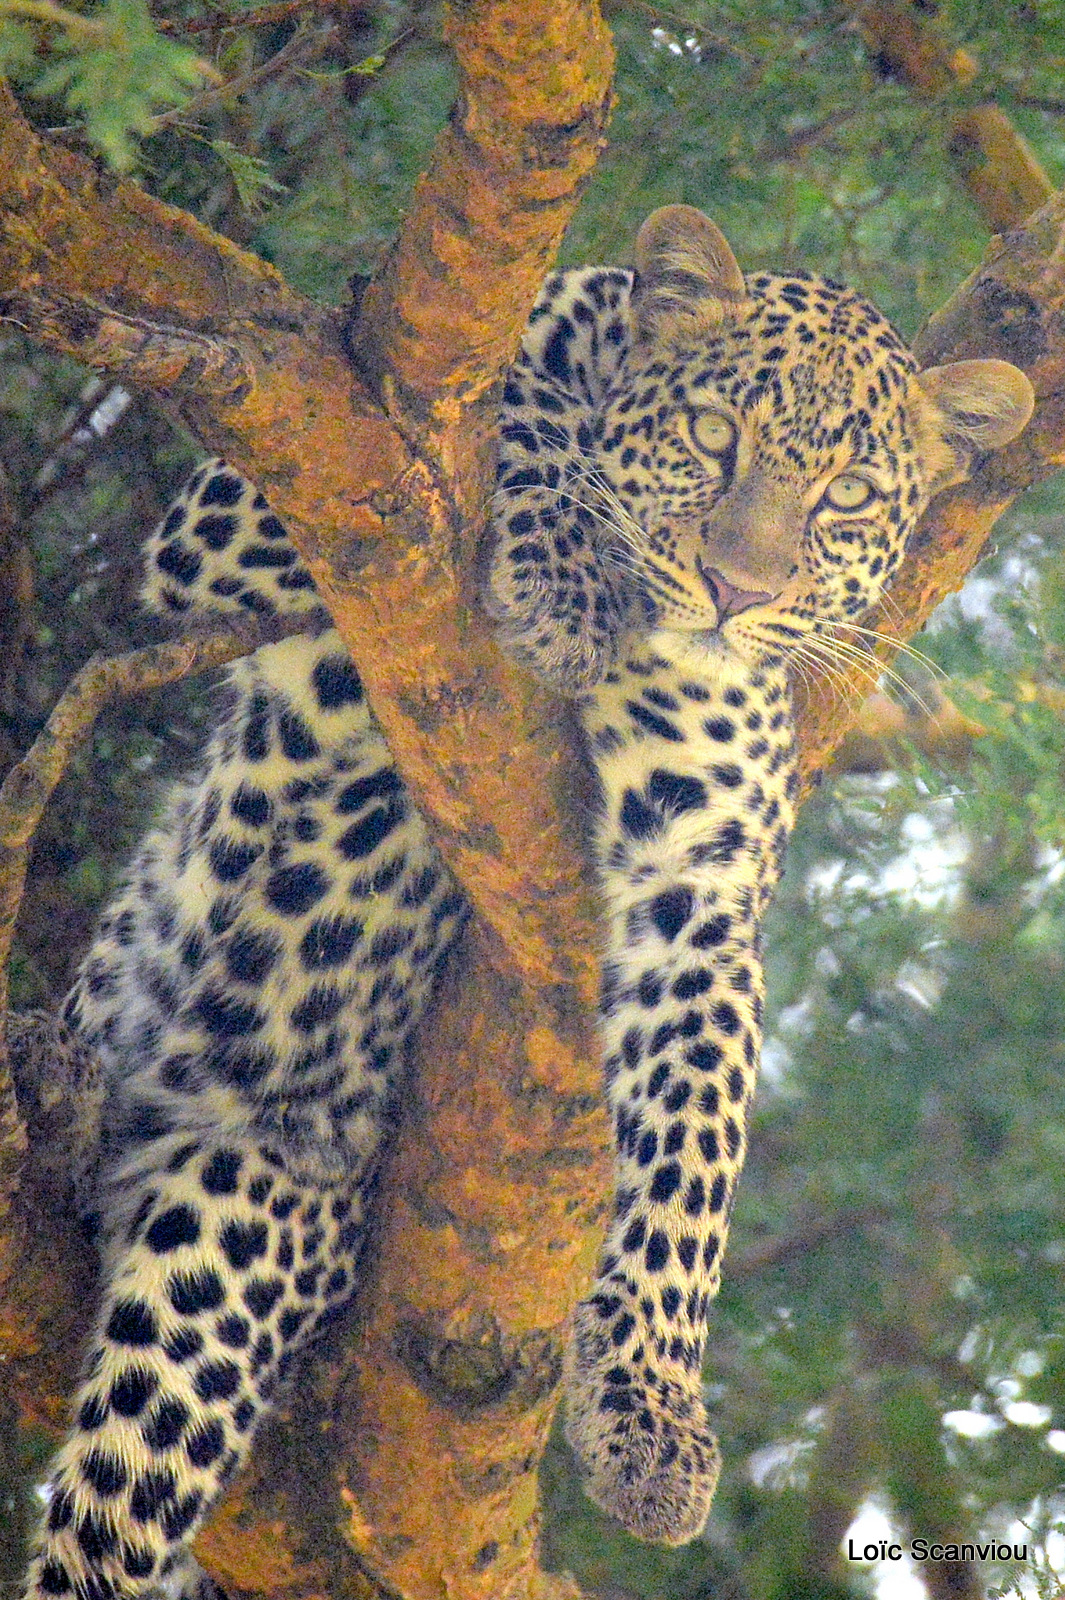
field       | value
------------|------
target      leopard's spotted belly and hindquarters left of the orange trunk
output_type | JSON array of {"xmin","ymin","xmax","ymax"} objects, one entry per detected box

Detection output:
[{"xmin": 29, "ymin": 461, "xmax": 464, "ymax": 1600}]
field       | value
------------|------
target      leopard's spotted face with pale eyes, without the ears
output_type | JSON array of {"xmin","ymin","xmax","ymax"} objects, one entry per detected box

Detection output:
[{"xmin": 596, "ymin": 275, "xmax": 931, "ymax": 665}]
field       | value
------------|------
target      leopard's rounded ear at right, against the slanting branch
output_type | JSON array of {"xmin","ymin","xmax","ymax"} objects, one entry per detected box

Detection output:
[{"xmin": 918, "ymin": 362, "xmax": 1035, "ymax": 488}]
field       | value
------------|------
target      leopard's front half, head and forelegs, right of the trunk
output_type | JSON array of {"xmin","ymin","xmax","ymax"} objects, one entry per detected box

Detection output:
[{"xmin": 488, "ymin": 206, "xmax": 1035, "ymax": 1546}]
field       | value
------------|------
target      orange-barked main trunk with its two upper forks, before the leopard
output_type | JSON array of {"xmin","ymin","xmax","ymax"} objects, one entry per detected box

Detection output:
[{"xmin": 0, "ymin": 3, "xmax": 609, "ymax": 1600}]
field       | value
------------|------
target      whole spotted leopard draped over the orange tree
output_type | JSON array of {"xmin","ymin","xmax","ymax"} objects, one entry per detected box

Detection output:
[{"xmin": 18, "ymin": 205, "xmax": 1033, "ymax": 1600}]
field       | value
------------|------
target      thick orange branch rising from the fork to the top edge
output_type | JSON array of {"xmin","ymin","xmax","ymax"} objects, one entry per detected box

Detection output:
[{"xmin": 355, "ymin": 0, "xmax": 612, "ymax": 421}]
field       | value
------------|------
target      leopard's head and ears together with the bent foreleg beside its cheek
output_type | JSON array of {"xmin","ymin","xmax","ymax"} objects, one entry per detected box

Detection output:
[{"xmin": 485, "ymin": 195, "xmax": 1035, "ymax": 694}]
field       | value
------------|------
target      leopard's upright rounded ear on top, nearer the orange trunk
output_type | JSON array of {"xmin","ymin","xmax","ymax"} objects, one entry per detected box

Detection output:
[{"xmin": 632, "ymin": 205, "xmax": 748, "ymax": 344}]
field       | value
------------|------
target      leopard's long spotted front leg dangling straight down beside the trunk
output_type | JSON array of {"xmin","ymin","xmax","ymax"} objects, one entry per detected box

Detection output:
[{"xmin": 566, "ymin": 634, "xmax": 795, "ymax": 1544}]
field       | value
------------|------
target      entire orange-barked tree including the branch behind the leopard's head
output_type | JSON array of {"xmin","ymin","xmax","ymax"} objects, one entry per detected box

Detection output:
[{"xmin": 0, "ymin": 0, "xmax": 1065, "ymax": 1597}]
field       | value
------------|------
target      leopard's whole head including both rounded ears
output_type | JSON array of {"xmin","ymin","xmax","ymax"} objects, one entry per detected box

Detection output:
[{"xmin": 592, "ymin": 206, "xmax": 1035, "ymax": 668}]
